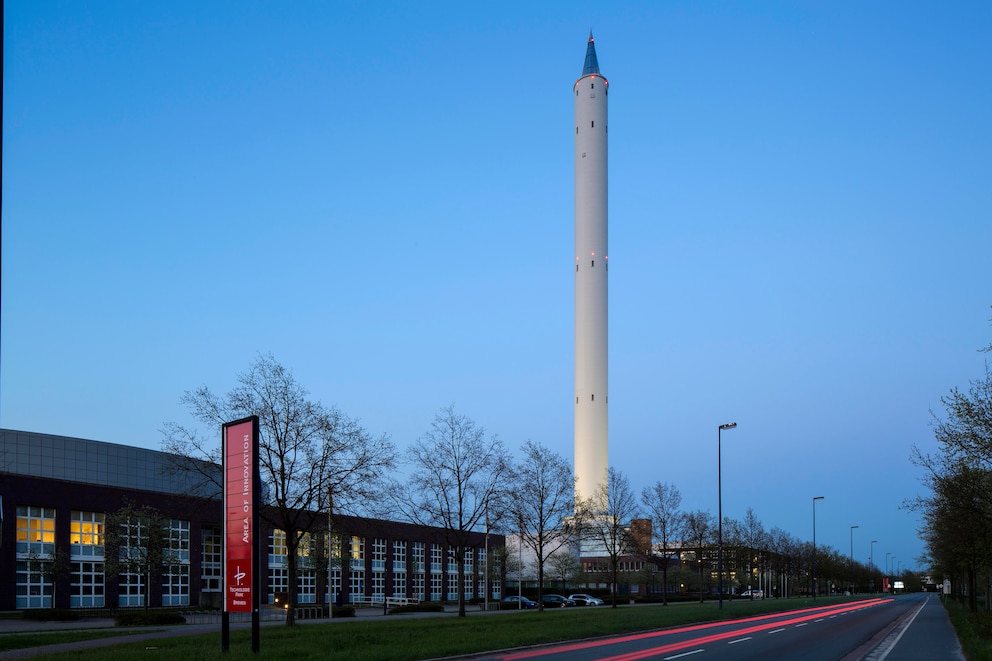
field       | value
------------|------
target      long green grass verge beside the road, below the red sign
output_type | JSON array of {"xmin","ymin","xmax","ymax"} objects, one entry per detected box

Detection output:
[{"xmin": 29, "ymin": 597, "xmax": 868, "ymax": 661}]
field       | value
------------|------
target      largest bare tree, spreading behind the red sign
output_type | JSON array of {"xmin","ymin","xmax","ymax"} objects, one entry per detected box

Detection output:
[{"xmin": 163, "ymin": 355, "xmax": 395, "ymax": 626}]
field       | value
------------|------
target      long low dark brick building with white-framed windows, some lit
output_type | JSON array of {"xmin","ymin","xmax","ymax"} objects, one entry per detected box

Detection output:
[{"xmin": 0, "ymin": 429, "xmax": 504, "ymax": 611}]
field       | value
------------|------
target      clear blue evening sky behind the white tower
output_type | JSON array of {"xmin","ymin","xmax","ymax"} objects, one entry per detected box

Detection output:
[{"xmin": 0, "ymin": 0, "xmax": 992, "ymax": 566}]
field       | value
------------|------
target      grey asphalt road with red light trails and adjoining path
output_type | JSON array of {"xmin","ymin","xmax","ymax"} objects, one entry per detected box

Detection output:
[{"xmin": 472, "ymin": 594, "xmax": 964, "ymax": 661}]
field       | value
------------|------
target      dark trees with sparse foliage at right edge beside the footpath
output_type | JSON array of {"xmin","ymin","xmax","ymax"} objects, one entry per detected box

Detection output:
[{"xmin": 907, "ymin": 328, "xmax": 992, "ymax": 612}]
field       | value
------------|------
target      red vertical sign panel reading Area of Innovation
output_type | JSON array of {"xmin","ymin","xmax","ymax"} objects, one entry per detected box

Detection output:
[{"xmin": 222, "ymin": 417, "xmax": 259, "ymax": 613}]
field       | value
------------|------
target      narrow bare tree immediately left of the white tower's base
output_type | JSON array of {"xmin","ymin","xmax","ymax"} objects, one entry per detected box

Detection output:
[{"xmin": 507, "ymin": 441, "xmax": 581, "ymax": 609}]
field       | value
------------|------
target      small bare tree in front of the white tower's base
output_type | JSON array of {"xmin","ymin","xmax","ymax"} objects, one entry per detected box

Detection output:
[{"xmin": 578, "ymin": 466, "xmax": 638, "ymax": 608}]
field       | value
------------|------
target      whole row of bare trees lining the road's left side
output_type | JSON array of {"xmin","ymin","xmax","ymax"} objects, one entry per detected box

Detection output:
[{"xmin": 163, "ymin": 355, "xmax": 912, "ymax": 625}]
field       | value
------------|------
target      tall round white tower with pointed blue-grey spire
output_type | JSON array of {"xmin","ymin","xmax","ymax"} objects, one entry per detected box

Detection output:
[{"xmin": 572, "ymin": 34, "xmax": 609, "ymax": 499}]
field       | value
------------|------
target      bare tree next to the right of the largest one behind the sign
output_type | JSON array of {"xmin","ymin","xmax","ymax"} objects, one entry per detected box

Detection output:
[{"xmin": 392, "ymin": 406, "xmax": 510, "ymax": 617}]
